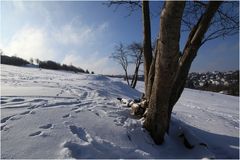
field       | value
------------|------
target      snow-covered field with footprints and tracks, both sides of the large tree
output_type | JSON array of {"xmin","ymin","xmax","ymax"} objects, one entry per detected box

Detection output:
[{"xmin": 1, "ymin": 65, "xmax": 239, "ymax": 159}]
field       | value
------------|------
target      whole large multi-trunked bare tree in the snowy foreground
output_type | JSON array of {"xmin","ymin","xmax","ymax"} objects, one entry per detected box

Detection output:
[{"xmin": 107, "ymin": 1, "xmax": 239, "ymax": 144}]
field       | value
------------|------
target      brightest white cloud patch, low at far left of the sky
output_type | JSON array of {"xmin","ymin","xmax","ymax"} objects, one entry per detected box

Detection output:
[{"xmin": 3, "ymin": 26, "xmax": 56, "ymax": 60}]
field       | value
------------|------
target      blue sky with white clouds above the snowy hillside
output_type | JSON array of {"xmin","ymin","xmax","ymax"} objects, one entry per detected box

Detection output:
[{"xmin": 0, "ymin": 1, "xmax": 239, "ymax": 74}]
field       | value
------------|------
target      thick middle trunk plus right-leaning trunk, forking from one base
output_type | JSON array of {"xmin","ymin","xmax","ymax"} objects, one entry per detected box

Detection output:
[{"xmin": 144, "ymin": 1, "xmax": 221, "ymax": 144}]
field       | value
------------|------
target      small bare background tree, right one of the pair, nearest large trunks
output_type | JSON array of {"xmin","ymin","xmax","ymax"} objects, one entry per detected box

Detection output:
[{"xmin": 128, "ymin": 42, "xmax": 143, "ymax": 88}]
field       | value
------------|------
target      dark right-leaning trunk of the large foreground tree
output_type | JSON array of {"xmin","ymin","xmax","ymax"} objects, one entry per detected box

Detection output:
[{"xmin": 168, "ymin": 1, "xmax": 222, "ymax": 129}]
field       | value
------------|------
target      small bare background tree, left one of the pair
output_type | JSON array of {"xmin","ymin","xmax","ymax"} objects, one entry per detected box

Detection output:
[{"xmin": 110, "ymin": 43, "xmax": 129, "ymax": 85}]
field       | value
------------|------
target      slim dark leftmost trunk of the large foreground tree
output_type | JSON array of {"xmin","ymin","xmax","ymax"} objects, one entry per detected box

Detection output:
[{"xmin": 142, "ymin": 1, "xmax": 152, "ymax": 96}]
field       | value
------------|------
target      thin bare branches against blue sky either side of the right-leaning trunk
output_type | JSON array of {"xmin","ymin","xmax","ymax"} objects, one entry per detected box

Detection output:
[{"xmin": 182, "ymin": 1, "xmax": 239, "ymax": 45}]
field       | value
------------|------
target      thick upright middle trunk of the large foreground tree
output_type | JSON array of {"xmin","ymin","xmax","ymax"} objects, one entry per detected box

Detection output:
[{"xmin": 144, "ymin": 1, "xmax": 185, "ymax": 144}]
